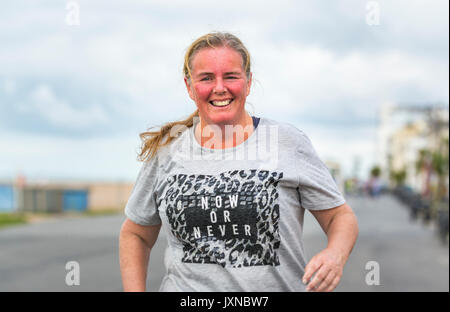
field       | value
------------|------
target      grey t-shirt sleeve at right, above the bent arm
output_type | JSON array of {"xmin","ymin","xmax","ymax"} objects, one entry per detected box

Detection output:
[{"xmin": 296, "ymin": 131, "xmax": 345, "ymax": 210}]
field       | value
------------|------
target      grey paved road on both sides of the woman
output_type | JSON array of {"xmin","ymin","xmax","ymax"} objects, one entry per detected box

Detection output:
[{"xmin": 0, "ymin": 196, "xmax": 449, "ymax": 292}]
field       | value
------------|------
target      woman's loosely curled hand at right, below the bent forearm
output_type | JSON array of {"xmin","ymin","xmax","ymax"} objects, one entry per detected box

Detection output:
[{"xmin": 303, "ymin": 248, "xmax": 345, "ymax": 292}]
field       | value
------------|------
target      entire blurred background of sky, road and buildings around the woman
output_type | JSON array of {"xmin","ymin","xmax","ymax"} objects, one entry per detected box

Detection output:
[{"xmin": 0, "ymin": 0, "xmax": 449, "ymax": 291}]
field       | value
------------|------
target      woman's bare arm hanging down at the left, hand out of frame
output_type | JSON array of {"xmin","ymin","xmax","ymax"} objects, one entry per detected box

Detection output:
[{"xmin": 119, "ymin": 219, "xmax": 161, "ymax": 291}]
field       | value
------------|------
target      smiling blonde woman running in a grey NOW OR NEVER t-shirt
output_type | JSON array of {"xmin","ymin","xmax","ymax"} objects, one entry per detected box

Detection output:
[{"xmin": 120, "ymin": 33, "xmax": 358, "ymax": 291}]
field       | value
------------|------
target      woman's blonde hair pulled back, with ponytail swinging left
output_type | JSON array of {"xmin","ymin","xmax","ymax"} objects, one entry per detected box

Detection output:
[{"xmin": 138, "ymin": 32, "xmax": 251, "ymax": 161}]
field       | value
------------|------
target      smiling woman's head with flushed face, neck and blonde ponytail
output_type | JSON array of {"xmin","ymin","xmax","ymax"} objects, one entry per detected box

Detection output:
[{"xmin": 139, "ymin": 32, "xmax": 253, "ymax": 160}]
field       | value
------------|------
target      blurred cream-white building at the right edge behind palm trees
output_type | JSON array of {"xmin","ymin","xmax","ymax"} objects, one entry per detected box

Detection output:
[{"xmin": 377, "ymin": 103, "xmax": 449, "ymax": 192}]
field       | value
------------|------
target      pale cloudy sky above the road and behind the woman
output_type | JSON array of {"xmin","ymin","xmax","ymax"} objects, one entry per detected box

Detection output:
[{"xmin": 0, "ymin": 0, "xmax": 449, "ymax": 181}]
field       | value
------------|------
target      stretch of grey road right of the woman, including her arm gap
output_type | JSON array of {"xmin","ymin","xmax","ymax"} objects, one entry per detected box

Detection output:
[{"xmin": 305, "ymin": 196, "xmax": 449, "ymax": 292}]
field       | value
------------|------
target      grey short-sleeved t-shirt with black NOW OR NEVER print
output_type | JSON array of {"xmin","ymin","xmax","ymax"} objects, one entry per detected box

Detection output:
[{"xmin": 125, "ymin": 118, "xmax": 345, "ymax": 291}]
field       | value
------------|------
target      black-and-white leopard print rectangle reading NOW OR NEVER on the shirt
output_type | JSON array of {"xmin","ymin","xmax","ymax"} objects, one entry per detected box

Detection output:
[{"xmin": 162, "ymin": 170, "xmax": 283, "ymax": 268}]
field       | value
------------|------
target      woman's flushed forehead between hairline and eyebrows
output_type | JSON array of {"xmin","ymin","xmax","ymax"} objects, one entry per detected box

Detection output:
[{"xmin": 192, "ymin": 47, "xmax": 243, "ymax": 73}]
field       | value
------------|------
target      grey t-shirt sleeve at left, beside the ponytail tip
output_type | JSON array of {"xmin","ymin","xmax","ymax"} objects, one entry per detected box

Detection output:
[{"xmin": 125, "ymin": 156, "xmax": 161, "ymax": 225}]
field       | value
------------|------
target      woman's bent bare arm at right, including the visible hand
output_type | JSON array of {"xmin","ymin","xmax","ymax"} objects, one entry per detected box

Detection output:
[{"xmin": 303, "ymin": 204, "xmax": 358, "ymax": 291}]
